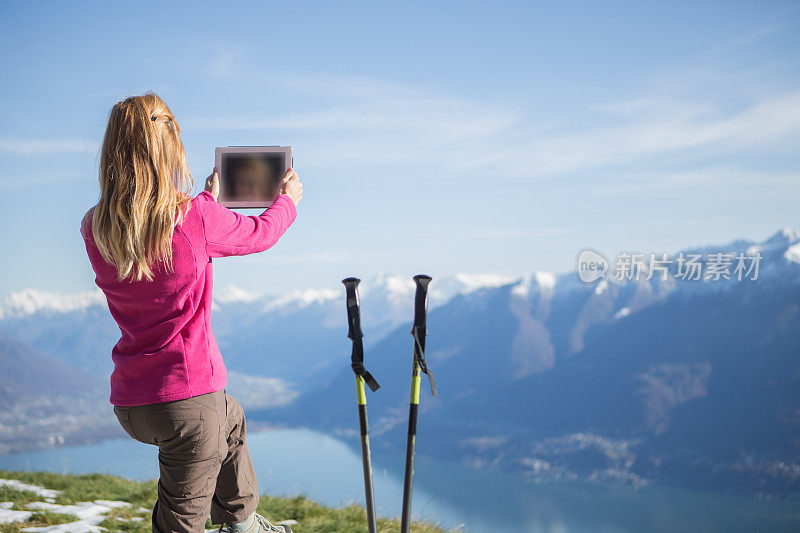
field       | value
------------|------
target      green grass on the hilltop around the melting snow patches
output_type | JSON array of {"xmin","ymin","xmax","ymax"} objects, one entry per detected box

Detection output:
[{"xmin": 0, "ymin": 470, "xmax": 444, "ymax": 533}]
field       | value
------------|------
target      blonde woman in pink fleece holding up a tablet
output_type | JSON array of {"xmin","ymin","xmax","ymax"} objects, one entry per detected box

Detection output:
[{"xmin": 81, "ymin": 94, "xmax": 303, "ymax": 533}]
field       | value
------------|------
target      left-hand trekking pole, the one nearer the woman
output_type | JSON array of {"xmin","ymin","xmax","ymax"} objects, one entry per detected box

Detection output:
[{"xmin": 342, "ymin": 278, "xmax": 380, "ymax": 533}]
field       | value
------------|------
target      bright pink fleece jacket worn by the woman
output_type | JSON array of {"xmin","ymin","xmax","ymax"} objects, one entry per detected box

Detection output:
[{"xmin": 81, "ymin": 192, "xmax": 297, "ymax": 406}]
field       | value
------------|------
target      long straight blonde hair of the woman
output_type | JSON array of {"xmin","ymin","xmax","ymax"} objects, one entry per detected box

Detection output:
[{"xmin": 92, "ymin": 93, "xmax": 194, "ymax": 281}]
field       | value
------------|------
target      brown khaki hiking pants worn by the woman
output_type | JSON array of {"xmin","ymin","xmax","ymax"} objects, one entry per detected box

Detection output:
[{"xmin": 114, "ymin": 390, "xmax": 258, "ymax": 533}]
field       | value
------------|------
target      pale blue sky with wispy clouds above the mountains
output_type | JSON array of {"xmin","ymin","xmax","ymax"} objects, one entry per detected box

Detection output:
[{"xmin": 0, "ymin": 1, "xmax": 800, "ymax": 298}]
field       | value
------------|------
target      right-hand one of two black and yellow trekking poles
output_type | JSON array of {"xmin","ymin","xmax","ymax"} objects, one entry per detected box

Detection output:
[{"xmin": 400, "ymin": 274, "xmax": 436, "ymax": 533}]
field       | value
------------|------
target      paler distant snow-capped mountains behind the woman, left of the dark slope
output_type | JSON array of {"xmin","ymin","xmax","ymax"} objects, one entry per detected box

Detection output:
[{"xmin": 0, "ymin": 274, "xmax": 509, "ymax": 405}]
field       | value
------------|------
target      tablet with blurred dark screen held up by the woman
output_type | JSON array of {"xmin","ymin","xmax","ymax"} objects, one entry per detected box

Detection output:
[{"xmin": 215, "ymin": 146, "xmax": 292, "ymax": 209}]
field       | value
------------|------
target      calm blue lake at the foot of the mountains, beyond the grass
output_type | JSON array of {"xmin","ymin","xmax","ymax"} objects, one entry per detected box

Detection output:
[{"xmin": 0, "ymin": 429, "xmax": 800, "ymax": 533}]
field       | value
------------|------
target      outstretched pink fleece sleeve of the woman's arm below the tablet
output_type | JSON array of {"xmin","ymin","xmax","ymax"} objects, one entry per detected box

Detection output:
[{"xmin": 195, "ymin": 191, "xmax": 297, "ymax": 257}]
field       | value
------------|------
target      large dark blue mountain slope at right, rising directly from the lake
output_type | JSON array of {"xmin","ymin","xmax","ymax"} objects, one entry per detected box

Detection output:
[{"xmin": 264, "ymin": 231, "xmax": 800, "ymax": 494}]
